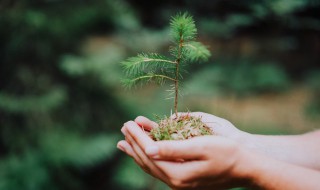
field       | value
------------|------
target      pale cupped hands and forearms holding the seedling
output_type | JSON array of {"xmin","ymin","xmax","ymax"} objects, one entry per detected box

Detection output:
[{"xmin": 118, "ymin": 112, "xmax": 320, "ymax": 189}]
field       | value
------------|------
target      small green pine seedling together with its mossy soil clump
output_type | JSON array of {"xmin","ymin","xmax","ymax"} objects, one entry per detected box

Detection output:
[{"xmin": 122, "ymin": 13, "xmax": 212, "ymax": 140}]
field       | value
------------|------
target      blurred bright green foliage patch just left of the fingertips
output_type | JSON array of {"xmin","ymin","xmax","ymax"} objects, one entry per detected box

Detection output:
[{"xmin": 39, "ymin": 131, "xmax": 120, "ymax": 168}]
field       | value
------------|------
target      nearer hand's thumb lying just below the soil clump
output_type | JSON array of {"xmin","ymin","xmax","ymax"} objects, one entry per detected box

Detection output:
[{"xmin": 145, "ymin": 137, "xmax": 204, "ymax": 160}]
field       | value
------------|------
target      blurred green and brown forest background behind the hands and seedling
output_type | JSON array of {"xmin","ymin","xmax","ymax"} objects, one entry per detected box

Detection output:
[{"xmin": 0, "ymin": 0, "xmax": 320, "ymax": 190}]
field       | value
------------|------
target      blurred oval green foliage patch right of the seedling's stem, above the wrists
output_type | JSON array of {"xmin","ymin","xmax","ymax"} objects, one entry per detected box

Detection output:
[{"xmin": 185, "ymin": 61, "xmax": 290, "ymax": 96}]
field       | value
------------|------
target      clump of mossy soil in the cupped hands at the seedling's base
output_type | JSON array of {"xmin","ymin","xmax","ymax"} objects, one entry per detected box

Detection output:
[{"xmin": 150, "ymin": 115, "xmax": 214, "ymax": 141}]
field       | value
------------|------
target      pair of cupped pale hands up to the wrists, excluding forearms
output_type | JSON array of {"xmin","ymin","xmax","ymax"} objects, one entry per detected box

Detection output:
[{"xmin": 118, "ymin": 112, "xmax": 252, "ymax": 189}]
